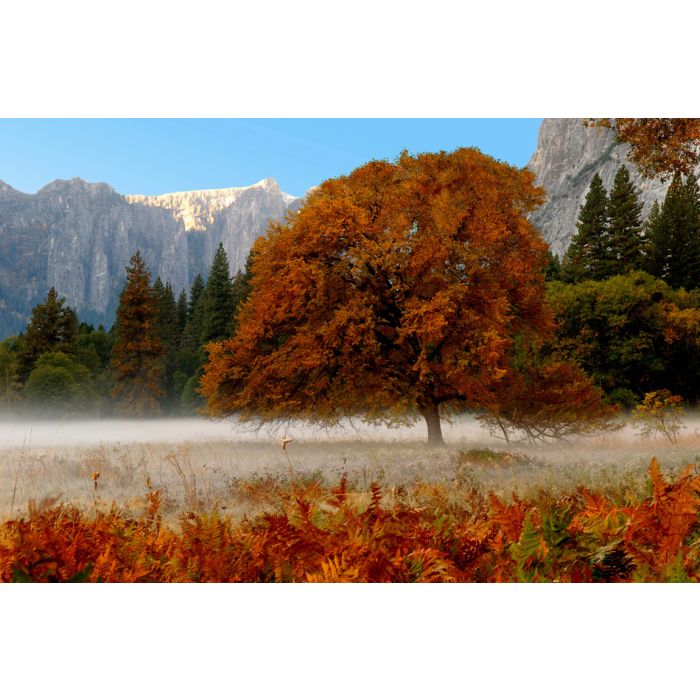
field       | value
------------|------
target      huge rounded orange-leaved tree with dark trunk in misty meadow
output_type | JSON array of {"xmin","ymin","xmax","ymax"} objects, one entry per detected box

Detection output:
[{"xmin": 201, "ymin": 149, "xmax": 551, "ymax": 442}]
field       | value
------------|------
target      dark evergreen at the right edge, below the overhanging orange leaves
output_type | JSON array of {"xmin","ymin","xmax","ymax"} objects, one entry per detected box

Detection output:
[{"xmin": 646, "ymin": 175, "xmax": 700, "ymax": 289}]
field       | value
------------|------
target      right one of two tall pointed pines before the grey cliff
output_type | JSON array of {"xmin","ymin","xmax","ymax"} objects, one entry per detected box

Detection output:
[{"xmin": 608, "ymin": 165, "xmax": 644, "ymax": 276}]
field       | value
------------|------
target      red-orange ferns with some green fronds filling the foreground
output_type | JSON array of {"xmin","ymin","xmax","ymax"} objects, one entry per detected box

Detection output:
[{"xmin": 0, "ymin": 459, "xmax": 700, "ymax": 582}]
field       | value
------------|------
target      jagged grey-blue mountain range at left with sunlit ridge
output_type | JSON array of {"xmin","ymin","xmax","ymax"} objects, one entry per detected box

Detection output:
[{"xmin": 0, "ymin": 178, "xmax": 301, "ymax": 338}]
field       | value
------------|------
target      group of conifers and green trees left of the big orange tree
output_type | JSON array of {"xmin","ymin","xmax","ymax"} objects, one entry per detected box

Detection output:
[{"xmin": 0, "ymin": 244, "xmax": 251, "ymax": 416}]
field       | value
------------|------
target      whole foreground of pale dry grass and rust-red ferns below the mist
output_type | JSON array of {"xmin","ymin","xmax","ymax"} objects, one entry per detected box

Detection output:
[{"xmin": 0, "ymin": 426, "xmax": 700, "ymax": 582}]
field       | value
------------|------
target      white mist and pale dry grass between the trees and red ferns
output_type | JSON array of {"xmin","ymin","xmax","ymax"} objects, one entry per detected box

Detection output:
[{"xmin": 0, "ymin": 415, "xmax": 700, "ymax": 519}]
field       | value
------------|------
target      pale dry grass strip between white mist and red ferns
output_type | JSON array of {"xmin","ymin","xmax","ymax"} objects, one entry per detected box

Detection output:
[{"xmin": 0, "ymin": 418, "xmax": 700, "ymax": 520}]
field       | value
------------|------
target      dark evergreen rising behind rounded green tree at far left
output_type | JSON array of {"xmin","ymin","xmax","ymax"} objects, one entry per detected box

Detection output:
[{"xmin": 17, "ymin": 287, "xmax": 78, "ymax": 383}]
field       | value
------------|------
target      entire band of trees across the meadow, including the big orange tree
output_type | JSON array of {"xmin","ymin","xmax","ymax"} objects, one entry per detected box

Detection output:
[{"xmin": 5, "ymin": 143, "xmax": 700, "ymax": 443}]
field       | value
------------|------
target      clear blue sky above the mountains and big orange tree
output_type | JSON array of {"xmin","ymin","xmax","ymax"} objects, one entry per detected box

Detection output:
[{"xmin": 0, "ymin": 119, "xmax": 542, "ymax": 195}]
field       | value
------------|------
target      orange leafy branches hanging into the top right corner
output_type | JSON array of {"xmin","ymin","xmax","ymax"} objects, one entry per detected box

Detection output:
[{"xmin": 595, "ymin": 118, "xmax": 700, "ymax": 177}]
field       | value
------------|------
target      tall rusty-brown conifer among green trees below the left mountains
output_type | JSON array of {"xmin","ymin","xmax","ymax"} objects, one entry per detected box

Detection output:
[{"xmin": 111, "ymin": 251, "xmax": 164, "ymax": 416}]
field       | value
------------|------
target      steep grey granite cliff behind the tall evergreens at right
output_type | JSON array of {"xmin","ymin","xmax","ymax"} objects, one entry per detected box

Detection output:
[{"xmin": 527, "ymin": 119, "xmax": 669, "ymax": 257}]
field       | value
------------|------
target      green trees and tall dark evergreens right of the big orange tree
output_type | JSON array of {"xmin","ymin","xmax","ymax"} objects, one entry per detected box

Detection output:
[{"xmin": 547, "ymin": 166, "xmax": 700, "ymax": 407}]
